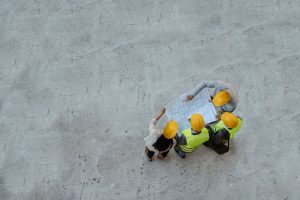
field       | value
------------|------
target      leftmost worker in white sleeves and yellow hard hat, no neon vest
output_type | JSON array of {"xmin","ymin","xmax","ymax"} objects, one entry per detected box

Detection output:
[{"xmin": 144, "ymin": 108, "xmax": 178, "ymax": 161}]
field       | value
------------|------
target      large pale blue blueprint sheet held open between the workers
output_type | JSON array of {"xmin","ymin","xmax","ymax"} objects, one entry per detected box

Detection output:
[{"xmin": 166, "ymin": 88, "xmax": 217, "ymax": 133}]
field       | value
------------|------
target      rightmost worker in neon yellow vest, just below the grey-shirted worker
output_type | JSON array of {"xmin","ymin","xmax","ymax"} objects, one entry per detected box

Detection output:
[{"xmin": 204, "ymin": 112, "xmax": 243, "ymax": 154}]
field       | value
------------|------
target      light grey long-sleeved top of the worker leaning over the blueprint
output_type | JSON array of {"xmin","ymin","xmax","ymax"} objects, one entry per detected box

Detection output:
[{"xmin": 191, "ymin": 81, "xmax": 238, "ymax": 112}]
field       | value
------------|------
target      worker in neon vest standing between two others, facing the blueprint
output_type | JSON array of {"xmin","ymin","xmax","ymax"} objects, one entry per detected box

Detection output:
[{"xmin": 174, "ymin": 114, "xmax": 209, "ymax": 158}]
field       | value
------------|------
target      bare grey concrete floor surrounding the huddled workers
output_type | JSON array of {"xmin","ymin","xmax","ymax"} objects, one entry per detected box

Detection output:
[{"xmin": 0, "ymin": 0, "xmax": 300, "ymax": 200}]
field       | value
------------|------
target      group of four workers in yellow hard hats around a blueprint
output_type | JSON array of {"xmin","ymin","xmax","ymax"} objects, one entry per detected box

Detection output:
[{"xmin": 144, "ymin": 81, "xmax": 243, "ymax": 161}]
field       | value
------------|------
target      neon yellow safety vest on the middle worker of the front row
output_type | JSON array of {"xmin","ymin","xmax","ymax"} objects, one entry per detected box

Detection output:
[{"xmin": 179, "ymin": 128, "xmax": 209, "ymax": 153}]
